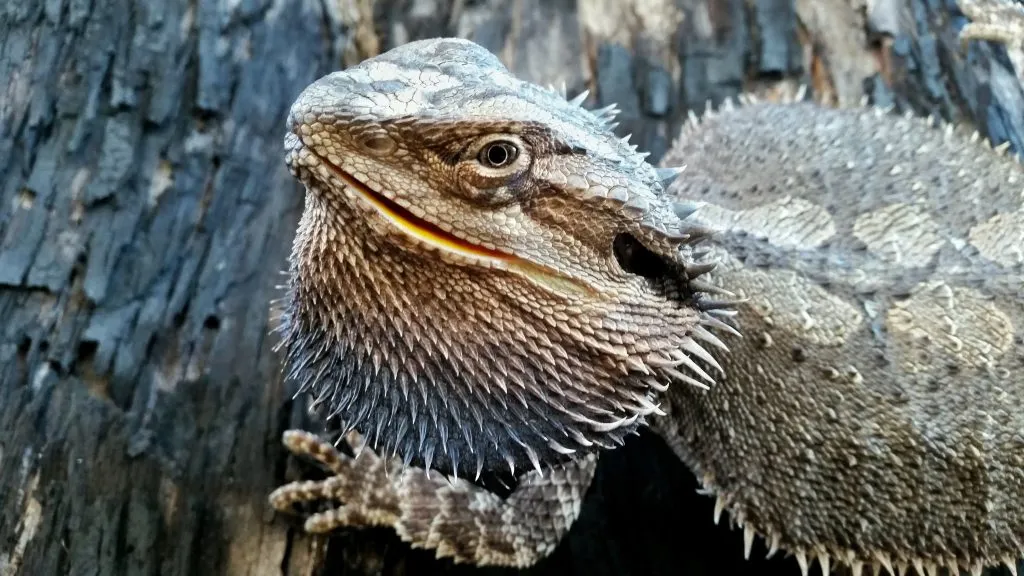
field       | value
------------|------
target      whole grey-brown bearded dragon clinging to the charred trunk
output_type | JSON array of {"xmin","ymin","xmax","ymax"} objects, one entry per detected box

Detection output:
[{"xmin": 270, "ymin": 2, "xmax": 1024, "ymax": 575}]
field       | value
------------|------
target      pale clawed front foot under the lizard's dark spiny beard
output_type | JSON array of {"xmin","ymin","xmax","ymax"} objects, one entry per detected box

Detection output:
[{"xmin": 269, "ymin": 430, "xmax": 401, "ymax": 534}]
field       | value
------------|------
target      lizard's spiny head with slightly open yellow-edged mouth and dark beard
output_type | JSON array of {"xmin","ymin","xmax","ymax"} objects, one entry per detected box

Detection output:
[{"xmin": 282, "ymin": 39, "xmax": 731, "ymax": 475}]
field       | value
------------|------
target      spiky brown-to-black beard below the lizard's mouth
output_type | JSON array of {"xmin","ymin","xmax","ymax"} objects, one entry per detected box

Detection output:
[{"xmin": 280, "ymin": 193, "xmax": 733, "ymax": 479}]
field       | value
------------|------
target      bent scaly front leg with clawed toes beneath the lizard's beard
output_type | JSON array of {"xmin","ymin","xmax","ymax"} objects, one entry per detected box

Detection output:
[{"xmin": 269, "ymin": 430, "xmax": 597, "ymax": 567}]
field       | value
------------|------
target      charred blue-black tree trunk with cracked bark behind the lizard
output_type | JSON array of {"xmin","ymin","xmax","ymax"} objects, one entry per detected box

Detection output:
[{"xmin": 0, "ymin": 0, "xmax": 1024, "ymax": 576}]
